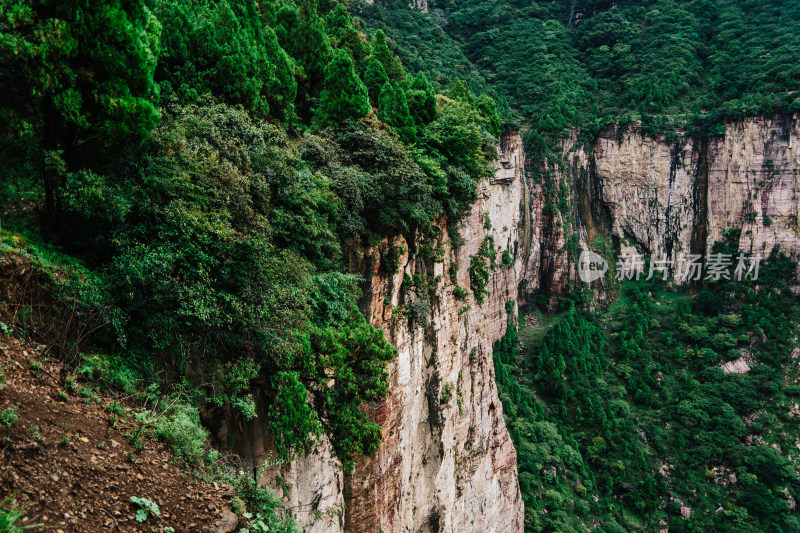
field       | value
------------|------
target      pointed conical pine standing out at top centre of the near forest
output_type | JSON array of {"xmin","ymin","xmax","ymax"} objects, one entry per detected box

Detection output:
[{"xmin": 318, "ymin": 50, "xmax": 370, "ymax": 126}]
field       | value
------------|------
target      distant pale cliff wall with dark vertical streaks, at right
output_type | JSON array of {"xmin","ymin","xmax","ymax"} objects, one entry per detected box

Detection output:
[{"xmin": 564, "ymin": 116, "xmax": 800, "ymax": 282}]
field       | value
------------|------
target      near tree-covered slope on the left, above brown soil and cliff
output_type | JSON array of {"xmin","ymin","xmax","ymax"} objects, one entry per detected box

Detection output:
[{"xmin": 0, "ymin": 0, "xmax": 500, "ymax": 527}]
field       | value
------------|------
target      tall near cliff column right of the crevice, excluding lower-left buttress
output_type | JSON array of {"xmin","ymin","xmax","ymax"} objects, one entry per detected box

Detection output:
[{"xmin": 346, "ymin": 130, "xmax": 524, "ymax": 532}]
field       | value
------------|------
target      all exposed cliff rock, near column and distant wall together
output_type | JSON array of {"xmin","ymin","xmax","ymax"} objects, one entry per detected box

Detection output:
[{"xmin": 227, "ymin": 115, "xmax": 800, "ymax": 533}]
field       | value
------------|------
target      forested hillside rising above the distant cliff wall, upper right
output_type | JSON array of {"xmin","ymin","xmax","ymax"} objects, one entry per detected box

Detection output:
[{"xmin": 372, "ymin": 0, "xmax": 800, "ymax": 143}]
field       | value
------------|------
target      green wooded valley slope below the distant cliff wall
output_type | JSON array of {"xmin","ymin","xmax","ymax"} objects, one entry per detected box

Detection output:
[{"xmin": 494, "ymin": 247, "xmax": 800, "ymax": 531}]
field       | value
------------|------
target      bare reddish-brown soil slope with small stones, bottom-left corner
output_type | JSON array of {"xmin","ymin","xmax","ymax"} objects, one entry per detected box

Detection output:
[{"xmin": 0, "ymin": 335, "xmax": 236, "ymax": 533}]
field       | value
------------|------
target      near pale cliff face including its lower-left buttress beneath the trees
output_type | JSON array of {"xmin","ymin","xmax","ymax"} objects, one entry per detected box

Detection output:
[{"xmin": 234, "ymin": 133, "xmax": 528, "ymax": 533}]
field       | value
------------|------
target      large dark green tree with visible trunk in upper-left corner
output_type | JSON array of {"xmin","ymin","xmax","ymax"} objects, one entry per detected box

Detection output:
[{"xmin": 0, "ymin": 0, "xmax": 161, "ymax": 226}]
